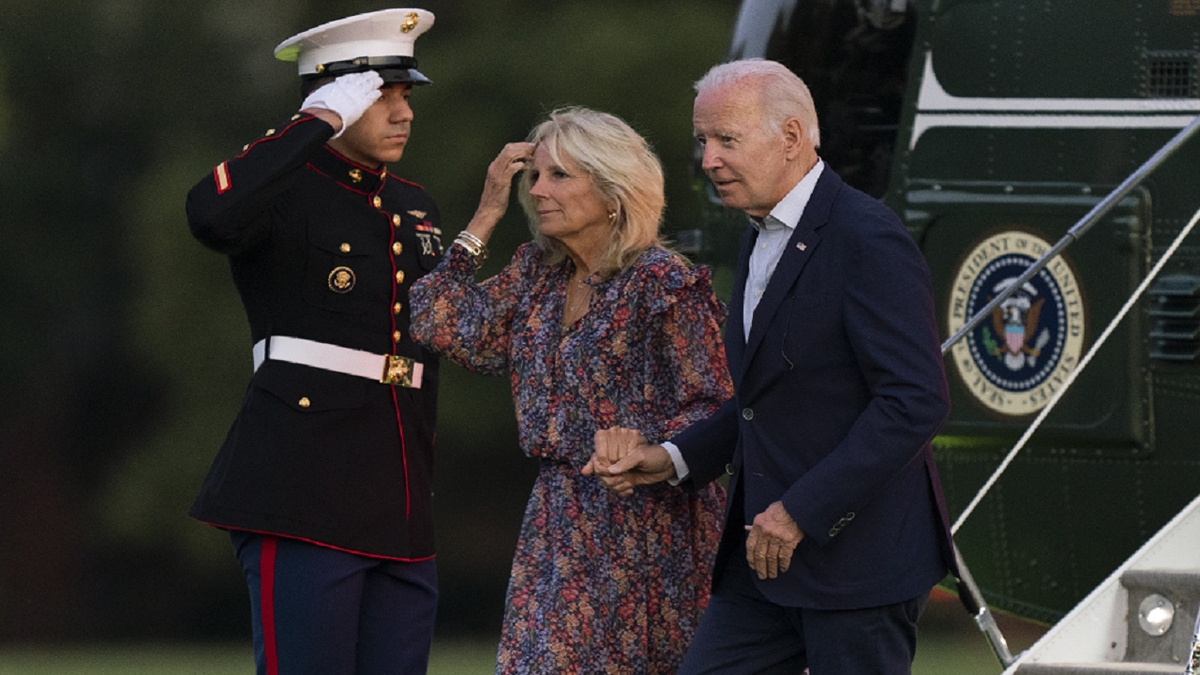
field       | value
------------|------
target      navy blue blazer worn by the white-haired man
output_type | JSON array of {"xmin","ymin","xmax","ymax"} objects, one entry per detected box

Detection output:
[{"xmin": 672, "ymin": 166, "xmax": 955, "ymax": 609}]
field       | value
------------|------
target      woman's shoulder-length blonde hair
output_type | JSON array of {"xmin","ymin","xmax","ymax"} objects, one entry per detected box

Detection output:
[{"xmin": 518, "ymin": 107, "xmax": 666, "ymax": 276}]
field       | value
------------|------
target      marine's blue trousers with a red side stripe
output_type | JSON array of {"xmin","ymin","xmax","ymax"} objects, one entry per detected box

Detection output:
[{"xmin": 230, "ymin": 530, "xmax": 438, "ymax": 675}]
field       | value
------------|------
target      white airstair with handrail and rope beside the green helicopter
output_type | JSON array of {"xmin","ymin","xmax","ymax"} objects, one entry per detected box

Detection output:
[{"xmin": 942, "ymin": 112, "xmax": 1200, "ymax": 675}]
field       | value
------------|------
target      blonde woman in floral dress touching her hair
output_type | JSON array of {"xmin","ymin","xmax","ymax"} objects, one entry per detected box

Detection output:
[{"xmin": 410, "ymin": 108, "xmax": 732, "ymax": 674}]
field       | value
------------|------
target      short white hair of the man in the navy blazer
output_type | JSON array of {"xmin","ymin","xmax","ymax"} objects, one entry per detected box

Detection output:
[{"xmin": 695, "ymin": 59, "xmax": 821, "ymax": 148}]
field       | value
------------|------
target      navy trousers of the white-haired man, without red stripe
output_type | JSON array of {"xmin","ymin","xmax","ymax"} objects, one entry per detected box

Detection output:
[{"xmin": 678, "ymin": 549, "xmax": 929, "ymax": 675}]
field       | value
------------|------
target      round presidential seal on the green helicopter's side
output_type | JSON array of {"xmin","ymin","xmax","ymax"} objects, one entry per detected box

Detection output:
[{"xmin": 948, "ymin": 231, "xmax": 1084, "ymax": 416}]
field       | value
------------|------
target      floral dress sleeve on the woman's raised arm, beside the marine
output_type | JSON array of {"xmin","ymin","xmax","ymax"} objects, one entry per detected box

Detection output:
[{"xmin": 408, "ymin": 240, "xmax": 532, "ymax": 375}]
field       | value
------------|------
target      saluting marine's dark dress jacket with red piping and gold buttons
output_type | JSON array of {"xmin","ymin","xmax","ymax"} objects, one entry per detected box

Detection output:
[{"xmin": 187, "ymin": 114, "xmax": 442, "ymax": 560}]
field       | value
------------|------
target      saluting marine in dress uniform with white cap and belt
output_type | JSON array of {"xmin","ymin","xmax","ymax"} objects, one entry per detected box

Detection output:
[{"xmin": 187, "ymin": 10, "xmax": 443, "ymax": 675}]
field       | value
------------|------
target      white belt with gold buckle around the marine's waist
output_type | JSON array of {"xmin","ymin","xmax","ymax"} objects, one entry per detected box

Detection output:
[{"xmin": 253, "ymin": 335, "xmax": 425, "ymax": 389}]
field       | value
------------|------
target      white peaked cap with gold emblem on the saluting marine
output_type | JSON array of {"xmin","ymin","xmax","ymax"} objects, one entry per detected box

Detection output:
[{"xmin": 275, "ymin": 8, "xmax": 433, "ymax": 84}]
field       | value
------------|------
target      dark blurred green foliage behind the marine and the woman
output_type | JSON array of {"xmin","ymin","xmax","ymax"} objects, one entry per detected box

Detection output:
[{"xmin": 0, "ymin": 0, "xmax": 737, "ymax": 644}]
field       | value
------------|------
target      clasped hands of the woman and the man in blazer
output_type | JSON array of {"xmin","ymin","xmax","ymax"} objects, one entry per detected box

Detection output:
[{"xmin": 583, "ymin": 426, "xmax": 674, "ymax": 497}]
